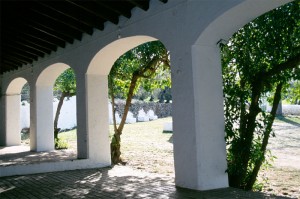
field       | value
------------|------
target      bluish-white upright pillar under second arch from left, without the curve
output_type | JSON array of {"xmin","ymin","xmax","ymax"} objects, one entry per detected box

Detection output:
[{"xmin": 30, "ymin": 86, "xmax": 54, "ymax": 151}]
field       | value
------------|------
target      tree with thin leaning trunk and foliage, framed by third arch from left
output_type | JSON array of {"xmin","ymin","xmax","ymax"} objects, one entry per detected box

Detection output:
[{"xmin": 109, "ymin": 41, "xmax": 171, "ymax": 164}]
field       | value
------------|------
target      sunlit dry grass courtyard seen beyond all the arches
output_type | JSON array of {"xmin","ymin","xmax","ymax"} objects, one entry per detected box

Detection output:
[{"xmin": 59, "ymin": 117, "xmax": 300, "ymax": 198}]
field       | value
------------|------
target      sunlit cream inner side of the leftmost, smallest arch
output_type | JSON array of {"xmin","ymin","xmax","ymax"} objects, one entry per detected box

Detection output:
[{"xmin": 5, "ymin": 77, "xmax": 27, "ymax": 146}]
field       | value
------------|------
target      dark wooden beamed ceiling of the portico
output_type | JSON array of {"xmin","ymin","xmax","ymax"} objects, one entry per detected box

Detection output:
[{"xmin": 0, "ymin": 0, "xmax": 168, "ymax": 74}]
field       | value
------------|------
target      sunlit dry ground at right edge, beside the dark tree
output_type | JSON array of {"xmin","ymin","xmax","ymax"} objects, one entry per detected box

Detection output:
[{"xmin": 260, "ymin": 119, "xmax": 300, "ymax": 199}]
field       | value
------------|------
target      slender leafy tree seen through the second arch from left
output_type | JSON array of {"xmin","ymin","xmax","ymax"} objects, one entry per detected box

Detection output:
[{"xmin": 54, "ymin": 68, "xmax": 76, "ymax": 146}]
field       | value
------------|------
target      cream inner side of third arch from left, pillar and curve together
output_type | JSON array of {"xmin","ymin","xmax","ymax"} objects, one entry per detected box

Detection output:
[{"xmin": 86, "ymin": 36, "xmax": 156, "ymax": 164}]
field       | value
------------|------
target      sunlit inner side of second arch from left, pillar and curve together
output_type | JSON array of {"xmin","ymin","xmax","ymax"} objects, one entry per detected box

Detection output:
[{"xmin": 30, "ymin": 63, "xmax": 70, "ymax": 151}]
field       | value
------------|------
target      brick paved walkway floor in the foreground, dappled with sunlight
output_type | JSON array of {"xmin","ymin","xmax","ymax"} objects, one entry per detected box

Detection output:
[{"xmin": 0, "ymin": 166, "xmax": 296, "ymax": 199}]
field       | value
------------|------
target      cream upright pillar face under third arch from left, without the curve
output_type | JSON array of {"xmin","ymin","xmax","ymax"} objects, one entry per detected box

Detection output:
[{"xmin": 86, "ymin": 75, "xmax": 111, "ymax": 165}]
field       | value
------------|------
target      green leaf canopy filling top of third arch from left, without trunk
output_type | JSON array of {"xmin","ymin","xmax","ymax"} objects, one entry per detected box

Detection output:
[{"xmin": 109, "ymin": 41, "xmax": 171, "ymax": 99}]
